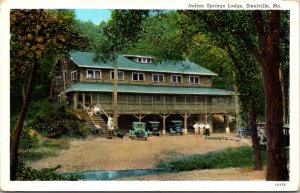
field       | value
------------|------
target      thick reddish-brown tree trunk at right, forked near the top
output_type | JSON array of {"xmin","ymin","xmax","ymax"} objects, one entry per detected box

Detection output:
[{"xmin": 253, "ymin": 11, "xmax": 289, "ymax": 181}]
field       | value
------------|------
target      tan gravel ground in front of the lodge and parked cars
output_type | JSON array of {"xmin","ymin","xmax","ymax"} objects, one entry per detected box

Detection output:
[{"xmin": 29, "ymin": 134, "xmax": 248, "ymax": 172}]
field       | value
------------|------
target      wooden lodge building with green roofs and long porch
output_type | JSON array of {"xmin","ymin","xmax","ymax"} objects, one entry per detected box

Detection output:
[{"xmin": 52, "ymin": 52, "xmax": 235, "ymax": 133}]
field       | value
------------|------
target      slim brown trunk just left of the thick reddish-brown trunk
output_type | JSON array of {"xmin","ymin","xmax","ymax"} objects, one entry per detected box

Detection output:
[{"xmin": 249, "ymin": 99, "xmax": 263, "ymax": 170}]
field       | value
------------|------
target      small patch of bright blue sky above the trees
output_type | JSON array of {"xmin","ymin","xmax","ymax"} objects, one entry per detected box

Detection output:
[{"xmin": 75, "ymin": 9, "xmax": 111, "ymax": 24}]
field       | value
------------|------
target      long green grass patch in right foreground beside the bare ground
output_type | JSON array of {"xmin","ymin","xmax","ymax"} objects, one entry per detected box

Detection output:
[{"xmin": 156, "ymin": 146, "xmax": 267, "ymax": 171}]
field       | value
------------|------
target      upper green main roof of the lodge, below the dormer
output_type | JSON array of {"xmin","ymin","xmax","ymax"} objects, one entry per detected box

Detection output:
[{"xmin": 70, "ymin": 52, "xmax": 217, "ymax": 76}]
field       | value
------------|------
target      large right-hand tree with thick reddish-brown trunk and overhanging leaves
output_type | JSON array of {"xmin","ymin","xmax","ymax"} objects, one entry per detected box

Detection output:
[{"xmin": 177, "ymin": 11, "xmax": 289, "ymax": 180}]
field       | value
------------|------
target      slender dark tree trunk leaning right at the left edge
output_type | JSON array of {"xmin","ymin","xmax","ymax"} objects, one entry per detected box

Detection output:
[{"xmin": 10, "ymin": 61, "xmax": 38, "ymax": 180}]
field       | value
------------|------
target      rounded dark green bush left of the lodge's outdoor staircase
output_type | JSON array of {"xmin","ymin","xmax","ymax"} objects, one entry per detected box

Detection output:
[{"xmin": 28, "ymin": 100, "xmax": 88, "ymax": 138}]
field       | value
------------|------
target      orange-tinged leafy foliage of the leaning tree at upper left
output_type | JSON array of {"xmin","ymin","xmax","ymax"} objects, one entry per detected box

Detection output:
[{"xmin": 10, "ymin": 9, "xmax": 86, "ymax": 116}]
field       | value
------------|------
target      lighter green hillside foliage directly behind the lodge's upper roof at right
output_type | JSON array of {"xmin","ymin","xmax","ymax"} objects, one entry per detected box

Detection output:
[{"xmin": 124, "ymin": 11, "xmax": 232, "ymax": 89}]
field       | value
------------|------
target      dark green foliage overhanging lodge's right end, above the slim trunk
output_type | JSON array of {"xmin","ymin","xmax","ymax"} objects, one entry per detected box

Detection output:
[{"xmin": 179, "ymin": 11, "xmax": 264, "ymax": 121}]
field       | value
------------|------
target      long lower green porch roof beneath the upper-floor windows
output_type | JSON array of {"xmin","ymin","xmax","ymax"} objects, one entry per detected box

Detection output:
[{"xmin": 66, "ymin": 82, "xmax": 234, "ymax": 95}]
